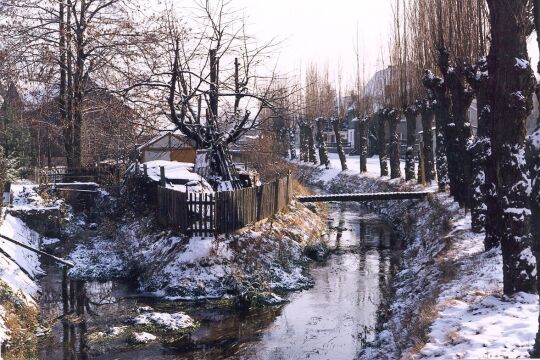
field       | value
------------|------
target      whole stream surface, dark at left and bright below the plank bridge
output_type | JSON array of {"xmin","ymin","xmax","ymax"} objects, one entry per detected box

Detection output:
[{"xmin": 39, "ymin": 205, "xmax": 399, "ymax": 359}]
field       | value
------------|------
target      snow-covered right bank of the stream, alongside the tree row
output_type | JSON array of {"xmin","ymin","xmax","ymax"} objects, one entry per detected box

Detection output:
[{"xmin": 302, "ymin": 157, "xmax": 538, "ymax": 359}]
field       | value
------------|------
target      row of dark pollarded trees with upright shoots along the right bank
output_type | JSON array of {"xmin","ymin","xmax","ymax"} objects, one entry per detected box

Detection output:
[{"xmin": 294, "ymin": 0, "xmax": 540, "ymax": 355}]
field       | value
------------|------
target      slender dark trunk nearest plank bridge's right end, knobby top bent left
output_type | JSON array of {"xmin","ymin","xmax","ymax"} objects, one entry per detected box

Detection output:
[{"xmin": 422, "ymin": 70, "xmax": 451, "ymax": 192}]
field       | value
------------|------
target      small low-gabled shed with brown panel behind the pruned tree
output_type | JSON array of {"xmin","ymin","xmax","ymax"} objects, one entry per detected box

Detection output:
[{"xmin": 138, "ymin": 132, "xmax": 197, "ymax": 163}]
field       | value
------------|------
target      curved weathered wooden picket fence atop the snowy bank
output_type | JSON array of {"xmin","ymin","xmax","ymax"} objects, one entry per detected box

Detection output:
[{"xmin": 157, "ymin": 175, "xmax": 293, "ymax": 235}]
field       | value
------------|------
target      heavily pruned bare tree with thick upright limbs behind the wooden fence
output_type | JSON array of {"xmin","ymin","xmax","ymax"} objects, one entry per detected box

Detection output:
[{"xmin": 122, "ymin": 0, "xmax": 282, "ymax": 187}]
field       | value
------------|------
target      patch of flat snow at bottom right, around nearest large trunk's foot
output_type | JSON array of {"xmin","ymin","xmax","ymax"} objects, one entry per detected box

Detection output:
[{"xmin": 420, "ymin": 236, "xmax": 539, "ymax": 359}]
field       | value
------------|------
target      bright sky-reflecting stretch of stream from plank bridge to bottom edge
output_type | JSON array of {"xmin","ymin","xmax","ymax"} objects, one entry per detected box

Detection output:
[{"xmin": 240, "ymin": 206, "xmax": 399, "ymax": 359}]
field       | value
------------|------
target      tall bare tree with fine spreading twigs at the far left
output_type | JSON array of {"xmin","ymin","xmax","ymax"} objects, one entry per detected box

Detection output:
[{"xmin": 0, "ymin": 0, "xmax": 146, "ymax": 168}]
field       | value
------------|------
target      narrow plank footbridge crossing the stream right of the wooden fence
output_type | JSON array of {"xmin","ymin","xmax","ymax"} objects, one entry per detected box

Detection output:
[{"xmin": 296, "ymin": 191, "xmax": 433, "ymax": 203}]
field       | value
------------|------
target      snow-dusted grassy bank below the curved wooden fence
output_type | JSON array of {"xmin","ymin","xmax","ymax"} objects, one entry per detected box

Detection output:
[{"xmin": 62, "ymin": 181, "xmax": 326, "ymax": 303}]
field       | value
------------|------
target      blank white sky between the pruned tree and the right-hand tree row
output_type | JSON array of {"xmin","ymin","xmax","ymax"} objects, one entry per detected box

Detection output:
[{"xmin": 232, "ymin": 0, "xmax": 392, "ymax": 87}]
